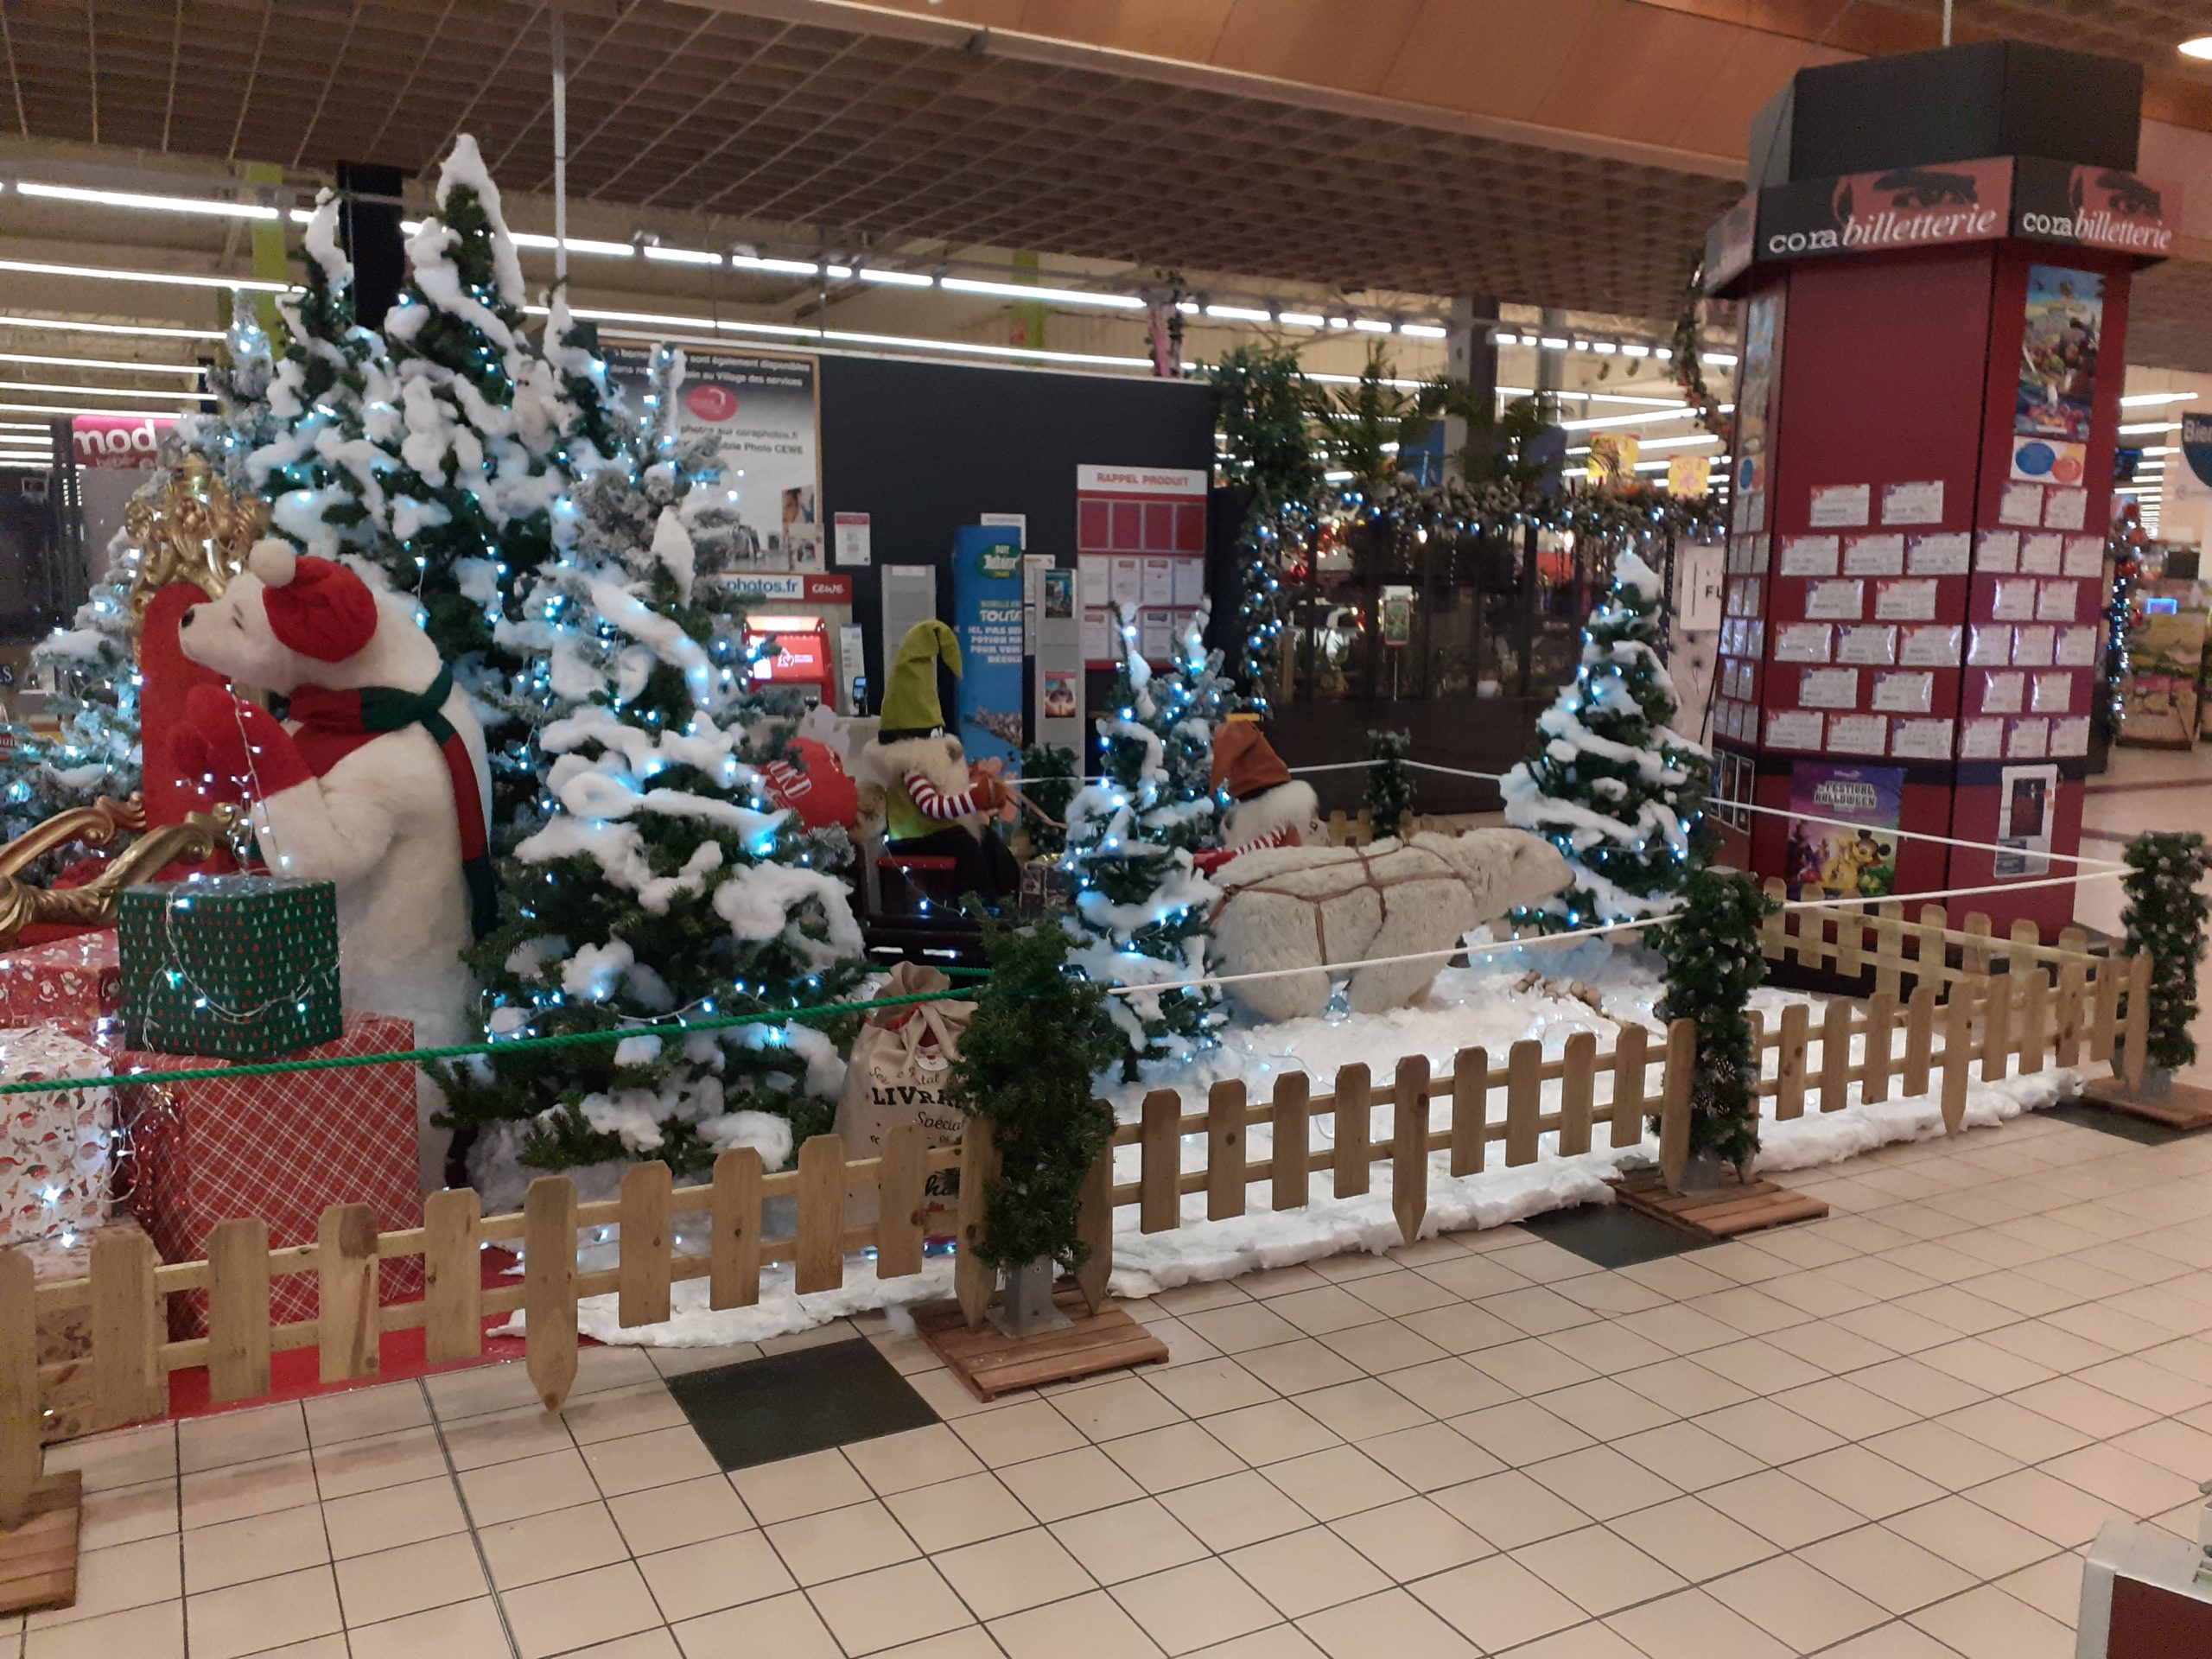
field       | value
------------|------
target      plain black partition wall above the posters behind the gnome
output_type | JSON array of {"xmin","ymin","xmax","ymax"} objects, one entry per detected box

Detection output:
[{"xmin": 817, "ymin": 356, "xmax": 1214, "ymax": 708}]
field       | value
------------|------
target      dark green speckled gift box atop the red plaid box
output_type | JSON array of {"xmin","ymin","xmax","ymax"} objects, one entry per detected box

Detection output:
[{"xmin": 118, "ymin": 876, "xmax": 345, "ymax": 1059}]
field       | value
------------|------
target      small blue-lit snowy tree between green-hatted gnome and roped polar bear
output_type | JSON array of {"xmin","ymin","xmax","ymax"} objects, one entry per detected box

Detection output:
[{"xmin": 1059, "ymin": 608, "xmax": 1225, "ymax": 1077}]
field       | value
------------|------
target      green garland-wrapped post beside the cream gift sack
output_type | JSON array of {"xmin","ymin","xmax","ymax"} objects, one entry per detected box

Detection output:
[{"xmin": 944, "ymin": 918, "xmax": 1123, "ymax": 1269}]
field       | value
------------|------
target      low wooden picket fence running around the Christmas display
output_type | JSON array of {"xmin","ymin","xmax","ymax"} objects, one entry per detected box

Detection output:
[{"xmin": 0, "ymin": 909, "xmax": 2150, "ymax": 1529}]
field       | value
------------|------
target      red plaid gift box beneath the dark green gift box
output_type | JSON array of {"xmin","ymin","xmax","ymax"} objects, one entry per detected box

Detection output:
[{"xmin": 118, "ymin": 1013, "xmax": 423, "ymax": 1340}]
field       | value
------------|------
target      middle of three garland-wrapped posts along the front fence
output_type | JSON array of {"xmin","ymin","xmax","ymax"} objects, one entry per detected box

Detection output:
[{"xmin": 1652, "ymin": 869, "xmax": 1774, "ymax": 1170}]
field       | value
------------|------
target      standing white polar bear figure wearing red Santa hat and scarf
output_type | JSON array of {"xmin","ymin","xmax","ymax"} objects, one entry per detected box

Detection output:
[{"xmin": 179, "ymin": 540, "xmax": 493, "ymax": 1192}]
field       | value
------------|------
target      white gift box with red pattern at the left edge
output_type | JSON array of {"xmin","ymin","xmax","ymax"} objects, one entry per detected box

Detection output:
[{"xmin": 0, "ymin": 1027, "xmax": 115, "ymax": 1245}]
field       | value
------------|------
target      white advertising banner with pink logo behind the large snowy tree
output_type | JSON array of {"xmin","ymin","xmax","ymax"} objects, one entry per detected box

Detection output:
[{"xmin": 606, "ymin": 345, "xmax": 823, "ymax": 575}]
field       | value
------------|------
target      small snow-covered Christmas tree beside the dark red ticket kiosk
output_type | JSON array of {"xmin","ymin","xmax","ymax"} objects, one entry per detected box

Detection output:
[{"xmin": 1500, "ymin": 549, "xmax": 1712, "ymax": 931}]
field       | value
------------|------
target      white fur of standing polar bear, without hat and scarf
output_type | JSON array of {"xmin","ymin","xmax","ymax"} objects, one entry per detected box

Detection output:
[{"xmin": 179, "ymin": 570, "xmax": 491, "ymax": 1192}]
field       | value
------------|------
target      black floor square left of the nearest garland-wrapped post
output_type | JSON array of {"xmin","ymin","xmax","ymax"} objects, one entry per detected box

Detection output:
[{"xmin": 668, "ymin": 1340, "xmax": 938, "ymax": 1469}]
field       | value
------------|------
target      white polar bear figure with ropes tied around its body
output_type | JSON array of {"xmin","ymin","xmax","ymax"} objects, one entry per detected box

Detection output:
[{"xmin": 1210, "ymin": 830, "xmax": 1568, "ymax": 1020}]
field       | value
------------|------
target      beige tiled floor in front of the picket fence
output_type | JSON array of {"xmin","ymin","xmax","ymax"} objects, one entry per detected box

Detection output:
[{"xmin": 26, "ymin": 1119, "xmax": 2212, "ymax": 1659}]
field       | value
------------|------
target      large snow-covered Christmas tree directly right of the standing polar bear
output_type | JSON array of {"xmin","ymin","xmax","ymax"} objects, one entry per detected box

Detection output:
[{"xmin": 440, "ymin": 343, "xmax": 865, "ymax": 1204}]
